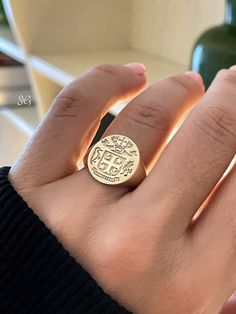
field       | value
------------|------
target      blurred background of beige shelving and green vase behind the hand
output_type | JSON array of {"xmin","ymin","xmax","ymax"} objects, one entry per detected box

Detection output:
[{"xmin": 0, "ymin": 0, "xmax": 236, "ymax": 166}]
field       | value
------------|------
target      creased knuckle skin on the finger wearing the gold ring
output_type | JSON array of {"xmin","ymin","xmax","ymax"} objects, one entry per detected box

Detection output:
[{"xmin": 125, "ymin": 102, "xmax": 171, "ymax": 131}]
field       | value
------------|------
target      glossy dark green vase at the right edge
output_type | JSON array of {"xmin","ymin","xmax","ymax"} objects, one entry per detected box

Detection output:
[{"xmin": 190, "ymin": 0, "xmax": 236, "ymax": 88}]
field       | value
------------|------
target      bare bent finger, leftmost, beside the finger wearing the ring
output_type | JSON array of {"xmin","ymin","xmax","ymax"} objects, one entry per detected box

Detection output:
[{"xmin": 10, "ymin": 64, "xmax": 146, "ymax": 186}]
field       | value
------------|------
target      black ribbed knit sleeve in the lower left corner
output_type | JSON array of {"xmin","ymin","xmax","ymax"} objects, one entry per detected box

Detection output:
[{"xmin": 0, "ymin": 167, "xmax": 130, "ymax": 314}]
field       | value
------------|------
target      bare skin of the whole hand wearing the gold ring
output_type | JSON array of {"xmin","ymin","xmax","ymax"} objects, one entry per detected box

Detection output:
[{"xmin": 9, "ymin": 64, "xmax": 236, "ymax": 314}]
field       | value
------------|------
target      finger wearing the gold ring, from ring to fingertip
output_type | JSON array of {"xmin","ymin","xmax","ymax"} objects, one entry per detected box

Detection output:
[{"xmin": 101, "ymin": 72, "xmax": 204, "ymax": 171}]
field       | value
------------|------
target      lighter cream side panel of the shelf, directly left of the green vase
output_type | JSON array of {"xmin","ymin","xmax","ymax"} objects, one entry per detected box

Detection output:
[{"xmin": 131, "ymin": 0, "xmax": 225, "ymax": 65}]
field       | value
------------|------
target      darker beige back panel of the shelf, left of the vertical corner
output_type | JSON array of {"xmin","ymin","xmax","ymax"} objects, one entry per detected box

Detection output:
[{"xmin": 4, "ymin": 0, "xmax": 131, "ymax": 53}]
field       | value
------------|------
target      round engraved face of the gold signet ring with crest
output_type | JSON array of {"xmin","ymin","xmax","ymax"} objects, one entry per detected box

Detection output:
[{"xmin": 87, "ymin": 135, "xmax": 140, "ymax": 185}]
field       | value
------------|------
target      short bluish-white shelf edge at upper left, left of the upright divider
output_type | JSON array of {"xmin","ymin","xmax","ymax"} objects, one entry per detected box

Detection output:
[{"xmin": 0, "ymin": 26, "xmax": 25, "ymax": 63}]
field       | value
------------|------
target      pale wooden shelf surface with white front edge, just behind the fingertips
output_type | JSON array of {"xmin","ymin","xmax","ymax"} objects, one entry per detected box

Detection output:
[{"xmin": 29, "ymin": 50, "xmax": 185, "ymax": 86}]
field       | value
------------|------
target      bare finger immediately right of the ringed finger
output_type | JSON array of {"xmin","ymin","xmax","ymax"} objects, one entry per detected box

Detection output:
[{"xmin": 138, "ymin": 69, "xmax": 236, "ymax": 232}]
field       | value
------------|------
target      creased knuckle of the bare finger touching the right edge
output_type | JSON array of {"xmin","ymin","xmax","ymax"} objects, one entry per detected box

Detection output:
[{"xmin": 194, "ymin": 104, "xmax": 236, "ymax": 149}]
